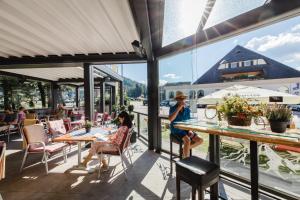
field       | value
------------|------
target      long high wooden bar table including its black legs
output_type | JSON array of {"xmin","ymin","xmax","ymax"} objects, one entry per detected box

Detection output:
[{"xmin": 174, "ymin": 120, "xmax": 300, "ymax": 200}]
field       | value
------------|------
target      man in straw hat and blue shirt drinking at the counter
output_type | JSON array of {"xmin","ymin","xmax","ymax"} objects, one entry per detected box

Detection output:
[{"xmin": 169, "ymin": 91, "xmax": 203, "ymax": 158}]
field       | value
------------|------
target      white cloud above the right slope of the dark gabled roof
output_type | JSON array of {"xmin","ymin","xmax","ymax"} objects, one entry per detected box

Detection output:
[{"xmin": 245, "ymin": 32, "xmax": 300, "ymax": 52}]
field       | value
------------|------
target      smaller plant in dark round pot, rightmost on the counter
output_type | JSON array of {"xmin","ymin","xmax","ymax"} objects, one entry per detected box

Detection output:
[{"xmin": 266, "ymin": 105, "xmax": 292, "ymax": 133}]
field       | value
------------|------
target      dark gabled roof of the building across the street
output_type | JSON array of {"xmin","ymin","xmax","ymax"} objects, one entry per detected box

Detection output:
[{"xmin": 193, "ymin": 45, "xmax": 300, "ymax": 84}]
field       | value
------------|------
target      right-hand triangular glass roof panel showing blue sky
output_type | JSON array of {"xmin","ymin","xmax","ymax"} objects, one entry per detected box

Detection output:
[{"xmin": 204, "ymin": 0, "xmax": 266, "ymax": 29}]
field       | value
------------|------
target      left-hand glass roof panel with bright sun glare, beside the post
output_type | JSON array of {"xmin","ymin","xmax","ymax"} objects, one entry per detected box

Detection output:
[{"xmin": 162, "ymin": 0, "xmax": 207, "ymax": 46}]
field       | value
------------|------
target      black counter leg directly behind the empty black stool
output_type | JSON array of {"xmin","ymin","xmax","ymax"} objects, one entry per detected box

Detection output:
[{"xmin": 209, "ymin": 134, "xmax": 220, "ymax": 200}]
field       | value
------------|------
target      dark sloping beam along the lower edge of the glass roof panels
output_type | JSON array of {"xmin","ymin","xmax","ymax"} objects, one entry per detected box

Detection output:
[{"xmin": 155, "ymin": 0, "xmax": 300, "ymax": 57}]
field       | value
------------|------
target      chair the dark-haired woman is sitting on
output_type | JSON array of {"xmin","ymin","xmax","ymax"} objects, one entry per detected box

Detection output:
[{"xmin": 98, "ymin": 128, "xmax": 133, "ymax": 179}]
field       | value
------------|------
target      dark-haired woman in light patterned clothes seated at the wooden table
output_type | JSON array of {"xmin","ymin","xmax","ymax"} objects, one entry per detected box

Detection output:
[{"xmin": 82, "ymin": 111, "xmax": 132, "ymax": 171}]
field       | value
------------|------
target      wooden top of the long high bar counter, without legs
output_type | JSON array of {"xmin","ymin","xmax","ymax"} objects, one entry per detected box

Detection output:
[{"xmin": 174, "ymin": 119, "xmax": 300, "ymax": 148}]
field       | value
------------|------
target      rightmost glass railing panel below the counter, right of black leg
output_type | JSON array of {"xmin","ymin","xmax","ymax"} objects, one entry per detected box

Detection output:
[{"xmin": 258, "ymin": 144, "xmax": 300, "ymax": 198}]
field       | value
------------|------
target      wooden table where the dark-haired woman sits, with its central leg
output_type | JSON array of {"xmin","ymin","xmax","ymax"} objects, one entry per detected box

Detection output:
[{"xmin": 53, "ymin": 127, "xmax": 116, "ymax": 165}]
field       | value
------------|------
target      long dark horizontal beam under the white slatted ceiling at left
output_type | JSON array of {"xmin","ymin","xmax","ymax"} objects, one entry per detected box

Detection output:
[{"xmin": 0, "ymin": 52, "xmax": 146, "ymax": 66}]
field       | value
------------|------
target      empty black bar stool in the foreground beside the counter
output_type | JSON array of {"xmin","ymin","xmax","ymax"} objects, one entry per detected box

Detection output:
[{"xmin": 176, "ymin": 156, "xmax": 220, "ymax": 200}]
